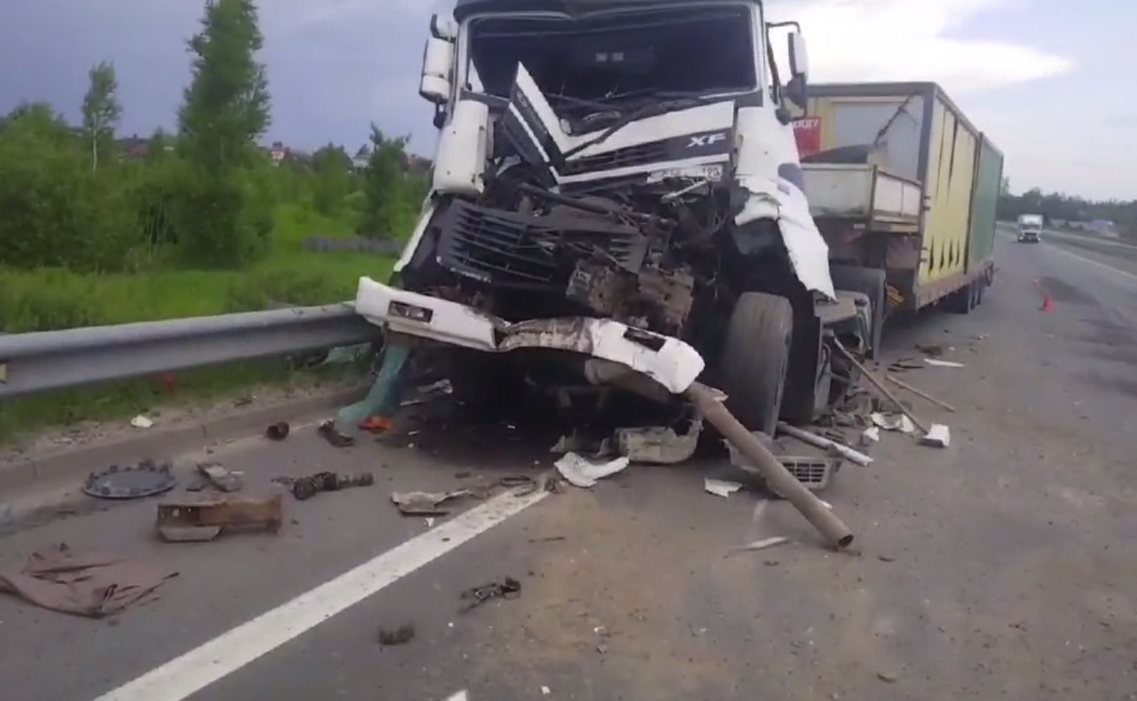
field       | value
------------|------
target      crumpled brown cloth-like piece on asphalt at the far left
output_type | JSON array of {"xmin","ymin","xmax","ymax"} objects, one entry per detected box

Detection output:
[{"xmin": 0, "ymin": 543, "xmax": 177, "ymax": 618}]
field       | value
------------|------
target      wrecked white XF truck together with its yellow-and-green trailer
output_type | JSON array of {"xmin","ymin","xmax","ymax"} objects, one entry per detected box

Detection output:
[{"xmin": 356, "ymin": 0, "xmax": 1003, "ymax": 434}]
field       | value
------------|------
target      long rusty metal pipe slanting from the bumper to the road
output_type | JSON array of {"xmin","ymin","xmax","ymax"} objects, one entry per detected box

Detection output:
[{"xmin": 687, "ymin": 382, "xmax": 853, "ymax": 550}]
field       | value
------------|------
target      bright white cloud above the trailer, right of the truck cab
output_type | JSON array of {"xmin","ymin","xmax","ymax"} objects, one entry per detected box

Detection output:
[{"xmin": 767, "ymin": 0, "xmax": 1074, "ymax": 94}]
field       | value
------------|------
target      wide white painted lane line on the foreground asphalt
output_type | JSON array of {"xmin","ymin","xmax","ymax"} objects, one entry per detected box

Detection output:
[{"xmin": 89, "ymin": 491, "xmax": 549, "ymax": 701}]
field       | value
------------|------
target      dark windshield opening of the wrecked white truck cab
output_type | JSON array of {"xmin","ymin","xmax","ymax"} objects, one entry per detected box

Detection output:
[{"xmin": 455, "ymin": 0, "xmax": 765, "ymax": 109}]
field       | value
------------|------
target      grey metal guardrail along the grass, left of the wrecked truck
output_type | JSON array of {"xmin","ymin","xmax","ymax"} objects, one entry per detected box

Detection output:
[{"xmin": 0, "ymin": 302, "xmax": 381, "ymax": 400}]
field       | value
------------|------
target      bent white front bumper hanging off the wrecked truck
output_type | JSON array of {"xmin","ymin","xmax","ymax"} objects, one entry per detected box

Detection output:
[{"xmin": 356, "ymin": 277, "xmax": 705, "ymax": 394}]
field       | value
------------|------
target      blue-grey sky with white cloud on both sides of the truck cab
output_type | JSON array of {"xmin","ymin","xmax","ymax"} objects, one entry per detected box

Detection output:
[{"xmin": 0, "ymin": 0, "xmax": 1137, "ymax": 199}]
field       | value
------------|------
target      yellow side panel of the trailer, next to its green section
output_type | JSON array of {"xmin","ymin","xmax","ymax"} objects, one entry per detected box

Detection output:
[{"xmin": 916, "ymin": 95, "xmax": 978, "ymax": 286}]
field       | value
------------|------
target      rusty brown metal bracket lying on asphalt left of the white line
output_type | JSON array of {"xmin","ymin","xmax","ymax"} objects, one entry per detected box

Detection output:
[{"xmin": 157, "ymin": 494, "xmax": 284, "ymax": 543}]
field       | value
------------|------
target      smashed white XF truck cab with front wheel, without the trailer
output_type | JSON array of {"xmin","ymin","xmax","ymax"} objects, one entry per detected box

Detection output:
[{"xmin": 356, "ymin": 0, "xmax": 873, "ymax": 434}]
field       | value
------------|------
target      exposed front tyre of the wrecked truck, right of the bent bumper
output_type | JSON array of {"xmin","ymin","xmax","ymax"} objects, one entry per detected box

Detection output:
[{"xmin": 719, "ymin": 292, "xmax": 794, "ymax": 436}]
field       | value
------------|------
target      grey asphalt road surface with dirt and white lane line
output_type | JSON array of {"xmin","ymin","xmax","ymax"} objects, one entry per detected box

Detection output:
[{"xmin": 0, "ymin": 230, "xmax": 1137, "ymax": 701}]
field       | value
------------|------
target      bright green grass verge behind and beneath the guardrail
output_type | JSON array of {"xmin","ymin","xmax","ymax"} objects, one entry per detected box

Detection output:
[{"xmin": 0, "ymin": 202, "xmax": 393, "ymax": 441}]
